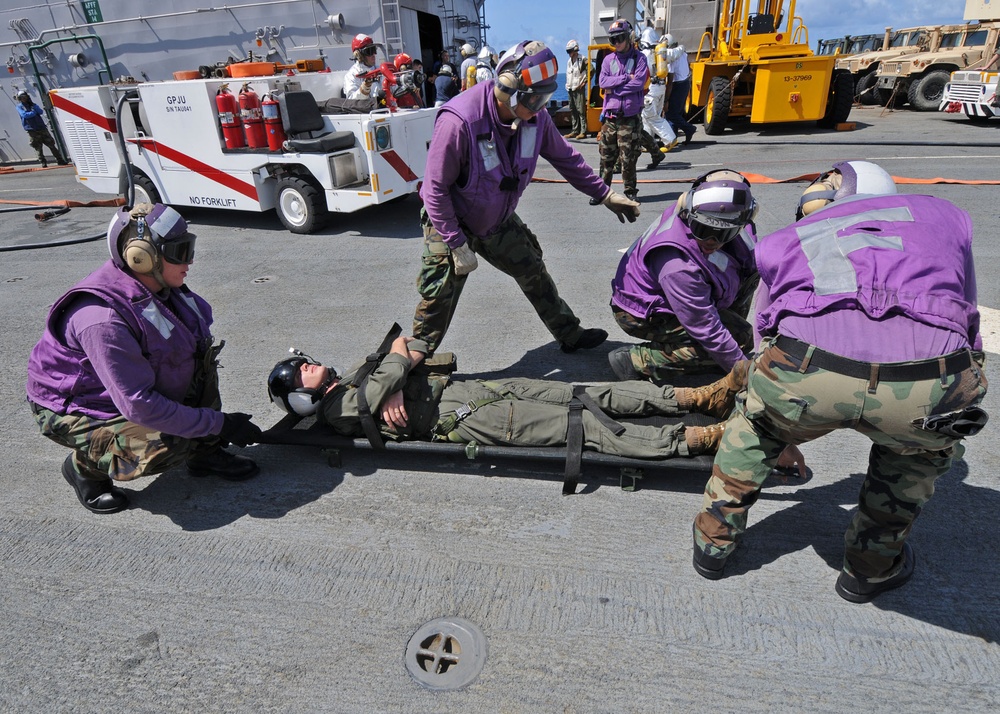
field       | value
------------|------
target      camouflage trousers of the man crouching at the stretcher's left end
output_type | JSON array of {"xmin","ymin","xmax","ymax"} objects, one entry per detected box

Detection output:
[{"xmin": 31, "ymin": 345, "xmax": 222, "ymax": 481}]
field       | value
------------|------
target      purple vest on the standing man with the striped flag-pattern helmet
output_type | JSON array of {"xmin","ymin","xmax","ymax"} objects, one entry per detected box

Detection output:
[{"xmin": 438, "ymin": 81, "xmax": 552, "ymax": 237}]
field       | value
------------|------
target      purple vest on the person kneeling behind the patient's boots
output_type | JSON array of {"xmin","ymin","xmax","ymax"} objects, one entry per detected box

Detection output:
[{"xmin": 611, "ymin": 207, "xmax": 754, "ymax": 319}]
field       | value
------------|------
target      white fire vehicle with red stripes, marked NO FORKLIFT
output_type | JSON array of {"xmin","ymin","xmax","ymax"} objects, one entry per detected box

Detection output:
[{"xmin": 49, "ymin": 70, "xmax": 436, "ymax": 233}]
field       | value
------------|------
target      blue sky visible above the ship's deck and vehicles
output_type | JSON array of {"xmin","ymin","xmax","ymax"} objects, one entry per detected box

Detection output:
[{"xmin": 486, "ymin": 0, "xmax": 976, "ymax": 58}]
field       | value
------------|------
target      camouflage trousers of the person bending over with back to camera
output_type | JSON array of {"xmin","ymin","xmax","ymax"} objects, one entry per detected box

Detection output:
[{"xmin": 694, "ymin": 339, "xmax": 987, "ymax": 582}]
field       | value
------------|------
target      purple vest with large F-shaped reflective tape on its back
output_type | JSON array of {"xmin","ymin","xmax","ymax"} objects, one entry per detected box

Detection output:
[{"xmin": 757, "ymin": 189, "xmax": 981, "ymax": 349}]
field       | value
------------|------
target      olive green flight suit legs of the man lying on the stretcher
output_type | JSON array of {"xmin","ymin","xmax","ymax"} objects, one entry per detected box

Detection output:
[{"xmin": 440, "ymin": 378, "xmax": 689, "ymax": 459}]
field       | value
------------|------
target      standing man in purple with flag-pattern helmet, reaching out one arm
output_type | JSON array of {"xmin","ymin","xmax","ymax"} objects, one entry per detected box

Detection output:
[{"xmin": 413, "ymin": 41, "xmax": 639, "ymax": 353}]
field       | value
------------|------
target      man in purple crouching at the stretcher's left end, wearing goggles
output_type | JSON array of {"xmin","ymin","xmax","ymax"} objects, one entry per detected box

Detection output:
[{"xmin": 27, "ymin": 203, "xmax": 261, "ymax": 513}]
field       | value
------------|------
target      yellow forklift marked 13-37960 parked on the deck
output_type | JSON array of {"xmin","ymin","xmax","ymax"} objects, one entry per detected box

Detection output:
[{"xmin": 688, "ymin": 0, "xmax": 853, "ymax": 134}]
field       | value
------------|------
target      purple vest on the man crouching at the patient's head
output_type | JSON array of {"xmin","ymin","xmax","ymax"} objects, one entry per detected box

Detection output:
[{"xmin": 27, "ymin": 260, "xmax": 212, "ymax": 419}]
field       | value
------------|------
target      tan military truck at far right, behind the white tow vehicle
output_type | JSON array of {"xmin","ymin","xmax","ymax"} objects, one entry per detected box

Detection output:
[{"xmin": 875, "ymin": 21, "xmax": 1000, "ymax": 112}]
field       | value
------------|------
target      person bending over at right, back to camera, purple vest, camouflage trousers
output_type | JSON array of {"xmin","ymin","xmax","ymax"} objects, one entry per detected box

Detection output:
[{"xmin": 694, "ymin": 161, "xmax": 987, "ymax": 602}]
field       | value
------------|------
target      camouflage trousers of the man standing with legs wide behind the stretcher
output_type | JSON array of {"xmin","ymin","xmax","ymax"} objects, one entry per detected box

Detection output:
[{"xmin": 413, "ymin": 204, "xmax": 583, "ymax": 353}]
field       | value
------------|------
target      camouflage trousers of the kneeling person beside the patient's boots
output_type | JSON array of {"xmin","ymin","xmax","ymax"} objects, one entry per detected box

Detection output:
[{"xmin": 611, "ymin": 273, "xmax": 760, "ymax": 382}]
